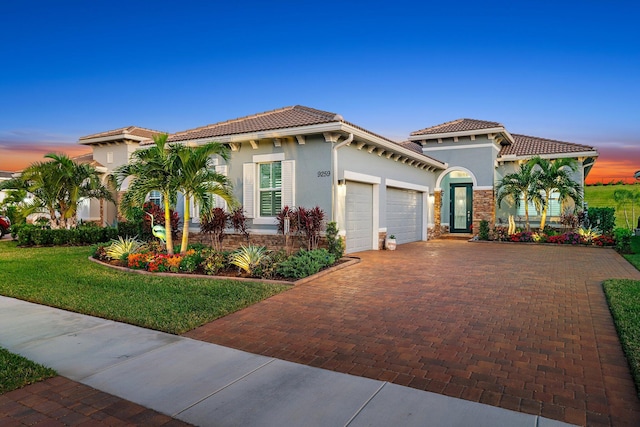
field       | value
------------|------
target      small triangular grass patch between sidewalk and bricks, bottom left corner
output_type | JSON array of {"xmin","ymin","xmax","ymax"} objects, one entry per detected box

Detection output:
[{"xmin": 0, "ymin": 347, "xmax": 56, "ymax": 394}]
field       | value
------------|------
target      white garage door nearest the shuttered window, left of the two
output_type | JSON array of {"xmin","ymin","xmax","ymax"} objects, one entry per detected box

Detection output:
[{"xmin": 345, "ymin": 181, "xmax": 373, "ymax": 253}]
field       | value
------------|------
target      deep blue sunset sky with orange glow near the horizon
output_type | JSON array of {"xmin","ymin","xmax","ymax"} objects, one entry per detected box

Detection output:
[{"xmin": 0, "ymin": 0, "xmax": 640, "ymax": 182}]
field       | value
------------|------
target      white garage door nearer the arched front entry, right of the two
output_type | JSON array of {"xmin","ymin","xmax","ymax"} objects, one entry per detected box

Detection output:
[{"xmin": 387, "ymin": 188, "xmax": 423, "ymax": 243}]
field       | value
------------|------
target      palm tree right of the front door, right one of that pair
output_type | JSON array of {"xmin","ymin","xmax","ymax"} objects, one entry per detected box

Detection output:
[{"xmin": 529, "ymin": 156, "xmax": 582, "ymax": 230}]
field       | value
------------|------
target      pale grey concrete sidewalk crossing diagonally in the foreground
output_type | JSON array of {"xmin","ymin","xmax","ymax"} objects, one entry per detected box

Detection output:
[{"xmin": 0, "ymin": 297, "xmax": 568, "ymax": 427}]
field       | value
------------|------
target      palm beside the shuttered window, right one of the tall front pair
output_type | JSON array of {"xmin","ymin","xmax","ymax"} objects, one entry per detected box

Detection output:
[{"xmin": 169, "ymin": 142, "xmax": 237, "ymax": 254}]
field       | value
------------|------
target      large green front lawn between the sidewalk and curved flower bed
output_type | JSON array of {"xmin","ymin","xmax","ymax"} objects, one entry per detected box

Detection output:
[{"xmin": 0, "ymin": 241, "xmax": 289, "ymax": 334}]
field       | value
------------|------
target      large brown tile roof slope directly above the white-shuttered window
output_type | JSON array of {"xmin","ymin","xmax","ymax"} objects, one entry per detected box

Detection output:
[{"xmin": 168, "ymin": 105, "xmax": 343, "ymax": 142}]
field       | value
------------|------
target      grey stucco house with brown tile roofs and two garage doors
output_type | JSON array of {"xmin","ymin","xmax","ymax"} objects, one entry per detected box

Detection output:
[{"xmin": 79, "ymin": 105, "xmax": 598, "ymax": 253}]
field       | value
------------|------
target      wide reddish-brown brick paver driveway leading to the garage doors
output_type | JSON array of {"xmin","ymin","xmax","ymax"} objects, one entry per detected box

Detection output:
[{"xmin": 187, "ymin": 240, "xmax": 640, "ymax": 425}]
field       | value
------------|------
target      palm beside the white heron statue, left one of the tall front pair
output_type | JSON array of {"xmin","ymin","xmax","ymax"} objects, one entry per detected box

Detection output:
[{"xmin": 114, "ymin": 134, "xmax": 178, "ymax": 255}]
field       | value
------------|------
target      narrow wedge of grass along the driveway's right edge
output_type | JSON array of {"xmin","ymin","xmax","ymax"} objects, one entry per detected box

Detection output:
[{"xmin": 603, "ymin": 279, "xmax": 640, "ymax": 392}]
